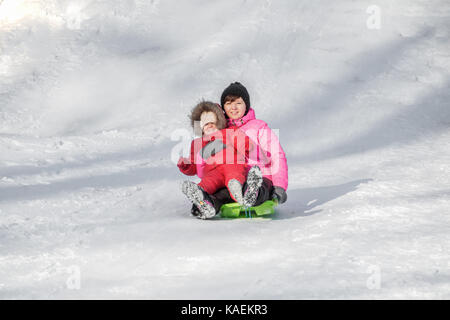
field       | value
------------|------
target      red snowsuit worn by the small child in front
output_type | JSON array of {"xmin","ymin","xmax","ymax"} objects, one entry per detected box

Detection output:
[{"xmin": 178, "ymin": 128, "xmax": 253, "ymax": 198}]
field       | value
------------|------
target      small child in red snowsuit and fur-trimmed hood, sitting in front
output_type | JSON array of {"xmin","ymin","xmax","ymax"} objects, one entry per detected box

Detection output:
[{"xmin": 178, "ymin": 101, "xmax": 262, "ymax": 219}]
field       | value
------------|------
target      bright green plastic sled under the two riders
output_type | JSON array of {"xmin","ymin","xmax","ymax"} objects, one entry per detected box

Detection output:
[{"xmin": 220, "ymin": 200, "xmax": 278, "ymax": 218}]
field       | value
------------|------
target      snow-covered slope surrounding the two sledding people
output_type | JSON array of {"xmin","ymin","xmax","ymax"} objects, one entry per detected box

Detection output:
[{"xmin": 0, "ymin": 0, "xmax": 450, "ymax": 299}]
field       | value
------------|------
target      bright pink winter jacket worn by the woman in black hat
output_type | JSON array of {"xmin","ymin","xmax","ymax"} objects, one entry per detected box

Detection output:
[{"xmin": 195, "ymin": 108, "xmax": 288, "ymax": 190}]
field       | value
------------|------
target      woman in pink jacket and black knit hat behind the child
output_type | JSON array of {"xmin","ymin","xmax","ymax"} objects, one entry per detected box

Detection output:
[{"xmin": 192, "ymin": 82, "xmax": 288, "ymax": 215}]
